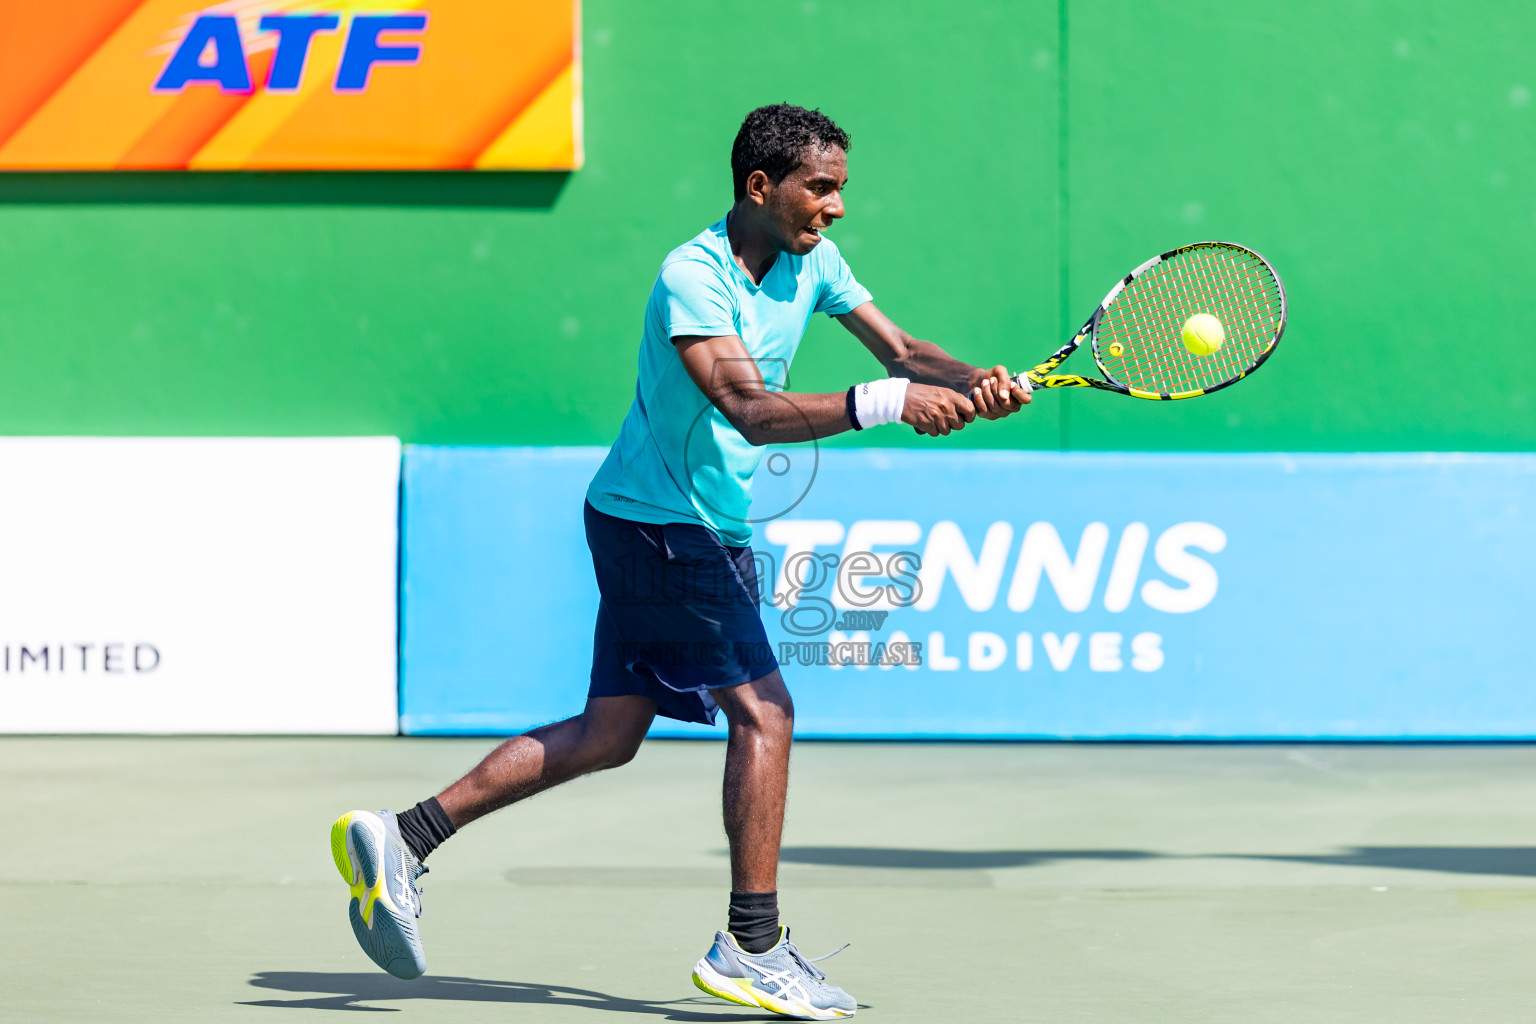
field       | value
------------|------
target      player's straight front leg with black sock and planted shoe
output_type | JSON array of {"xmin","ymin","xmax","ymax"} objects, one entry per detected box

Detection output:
[{"xmin": 693, "ymin": 669, "xmax": 857, "ymax": 1019}]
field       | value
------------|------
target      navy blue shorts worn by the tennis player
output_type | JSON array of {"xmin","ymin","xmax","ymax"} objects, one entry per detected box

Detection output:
[{"xmin": 582, "ymin": 504, "xmax": 779, "ymax": 725}]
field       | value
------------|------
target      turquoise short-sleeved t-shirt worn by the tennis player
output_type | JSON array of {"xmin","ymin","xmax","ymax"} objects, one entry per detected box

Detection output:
[{"xmin": 587, "ymin": 218, "xmax": 869, "ymax": 547}]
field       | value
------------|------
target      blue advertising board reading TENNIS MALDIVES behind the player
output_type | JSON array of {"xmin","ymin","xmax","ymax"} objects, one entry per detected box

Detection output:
[{"xmin": 401, "ymin": 447, "xmax": 1536, "ymax": 738}]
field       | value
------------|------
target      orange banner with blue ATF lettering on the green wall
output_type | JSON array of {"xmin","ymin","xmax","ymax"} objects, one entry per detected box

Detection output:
[{"xmin": 0, "ymin": 0, "xmax": 582, "ymax": 170}]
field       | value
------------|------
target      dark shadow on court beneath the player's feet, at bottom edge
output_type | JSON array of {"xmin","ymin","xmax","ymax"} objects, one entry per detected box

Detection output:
[{"xmin": 247, "ymin": 970, "xmax": 780, "ymax": 1024}]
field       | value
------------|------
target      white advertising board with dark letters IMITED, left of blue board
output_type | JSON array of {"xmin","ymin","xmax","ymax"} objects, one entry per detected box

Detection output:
[{"xmin": 0, "ymin": 438, "xmax": 399, "ymax": 734}]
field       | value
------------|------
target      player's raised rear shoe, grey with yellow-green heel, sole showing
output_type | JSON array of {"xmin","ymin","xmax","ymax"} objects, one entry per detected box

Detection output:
[{"xmin": 330, "ymin": 811, "xmax": 427, "ymax": 981}]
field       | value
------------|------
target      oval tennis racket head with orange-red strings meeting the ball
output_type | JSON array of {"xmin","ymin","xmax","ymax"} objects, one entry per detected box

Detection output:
[{"xmin": 1092, "ymin": 241, "xmax": 1286, "ymax": 401}]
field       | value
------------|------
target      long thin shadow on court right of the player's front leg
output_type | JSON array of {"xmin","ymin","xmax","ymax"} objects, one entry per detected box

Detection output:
[{"xmin": 780, "ymin": 846, "xmax": 1536, "ymax": 878}]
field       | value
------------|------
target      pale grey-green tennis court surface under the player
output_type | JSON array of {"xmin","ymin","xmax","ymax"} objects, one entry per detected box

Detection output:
[{"xmin": 0, "ymin": 738, "xmax": 1536, "ymax": 1024}]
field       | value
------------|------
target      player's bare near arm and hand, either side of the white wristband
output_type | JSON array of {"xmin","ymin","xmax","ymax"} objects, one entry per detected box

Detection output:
[{"xmin": 673, "ymin": 335, "xmax": 975, "ymax": 445}]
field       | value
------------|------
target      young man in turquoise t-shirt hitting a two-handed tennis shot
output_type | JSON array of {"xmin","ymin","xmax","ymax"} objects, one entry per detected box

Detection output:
[{"xmin": 332, "ymin": 104, "xmax": 1029, "ymax": 1019}]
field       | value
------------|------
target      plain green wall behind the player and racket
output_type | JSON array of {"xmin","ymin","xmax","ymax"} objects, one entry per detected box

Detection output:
[{"xmin": 0, "ymin": 0, "xmax": 1536, "ymax": 450}]
